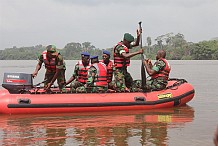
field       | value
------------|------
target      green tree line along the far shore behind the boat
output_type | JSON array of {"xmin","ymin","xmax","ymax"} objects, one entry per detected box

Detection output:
[{"xmin": 0, "ymin": 33, "xmax": 218, "ymax": 60}]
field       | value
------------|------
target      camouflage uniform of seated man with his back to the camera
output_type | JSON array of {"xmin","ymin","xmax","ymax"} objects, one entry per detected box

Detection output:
[{"xmin": 83, "ymin": 66, "xmax": 107, "ymax": 93}]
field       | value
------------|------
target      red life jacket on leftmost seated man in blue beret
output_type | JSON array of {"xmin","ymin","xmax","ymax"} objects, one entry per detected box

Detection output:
[{"xmin": 77, "ymin": 60, "xmax": 91, "ymax": 84}]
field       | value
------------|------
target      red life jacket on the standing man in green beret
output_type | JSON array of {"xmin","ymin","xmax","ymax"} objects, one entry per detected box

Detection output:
[{"xmin": 114, "ymin": 42, "xmax": 130, "ymax": 68}]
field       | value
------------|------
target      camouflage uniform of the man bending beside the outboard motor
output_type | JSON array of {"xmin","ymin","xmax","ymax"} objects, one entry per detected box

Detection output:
[{"xmin": 39, "ymin": 53, "xmax": 66, "ymax": 92}]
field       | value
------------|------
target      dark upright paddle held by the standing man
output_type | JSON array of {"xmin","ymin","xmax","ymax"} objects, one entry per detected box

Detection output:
[{"xmin": 139, "ymin": 21, "xmax": 146, "ymax": 91}]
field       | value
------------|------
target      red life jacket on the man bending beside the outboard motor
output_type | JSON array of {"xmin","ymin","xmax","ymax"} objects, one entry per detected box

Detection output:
[{"xmin": 42, "ymin": 50, "xmax": 58, "ymax": 72}]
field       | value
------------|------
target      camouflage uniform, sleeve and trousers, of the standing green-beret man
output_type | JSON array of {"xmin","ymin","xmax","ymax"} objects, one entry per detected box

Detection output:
[{"xmin": 114, "ymin": 42, "xmax": 133, "ymax": 92}]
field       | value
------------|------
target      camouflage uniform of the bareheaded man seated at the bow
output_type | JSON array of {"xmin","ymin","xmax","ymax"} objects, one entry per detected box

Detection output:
[{"xmin": 146, "ymin": 60, "xmax": 168, "ymax": 91}]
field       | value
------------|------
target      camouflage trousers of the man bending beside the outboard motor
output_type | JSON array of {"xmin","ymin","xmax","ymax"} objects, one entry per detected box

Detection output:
[{"xmin": 44, "ymin": 70, "xmax": 66, "ymax": 92}]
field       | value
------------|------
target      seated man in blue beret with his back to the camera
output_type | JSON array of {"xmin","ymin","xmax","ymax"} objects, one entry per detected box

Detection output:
[{"xmin": 86, "ymin": 56, "xmax": 108, "ymax": 93}]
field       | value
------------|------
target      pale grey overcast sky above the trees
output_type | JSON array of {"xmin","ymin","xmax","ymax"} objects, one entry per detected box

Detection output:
[{"xmin": 0, "ymin": 0, "xmax": 218, "ymax": 49}]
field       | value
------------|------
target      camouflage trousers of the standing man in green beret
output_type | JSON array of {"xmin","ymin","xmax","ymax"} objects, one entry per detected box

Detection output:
[{"xmin": 113, "ymin": 68, "xmax": 133, "ymax": 92}]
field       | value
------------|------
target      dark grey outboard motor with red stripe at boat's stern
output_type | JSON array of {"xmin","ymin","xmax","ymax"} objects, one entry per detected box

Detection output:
[{"xmin": 2, "ymin": 73, "xmax": 33, "ymax": 94}]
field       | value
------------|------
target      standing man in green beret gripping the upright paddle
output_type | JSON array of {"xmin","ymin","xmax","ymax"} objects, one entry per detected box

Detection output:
[{"xmin": 114, "ymin": 30, "xmax": 143, "ymax": 92}]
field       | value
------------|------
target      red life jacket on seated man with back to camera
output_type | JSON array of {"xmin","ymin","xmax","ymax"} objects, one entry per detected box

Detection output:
[{"xmin": 92, "ymin": 62, "xmax": 107, "ymax": 87}]
